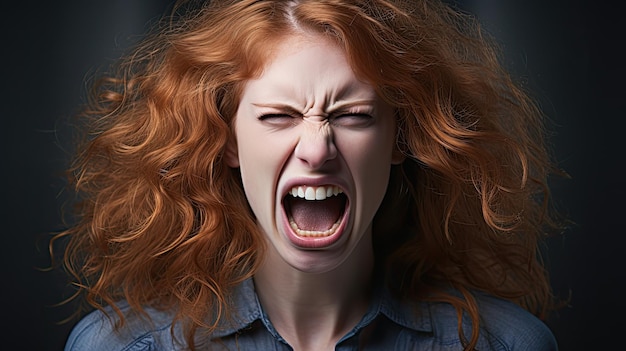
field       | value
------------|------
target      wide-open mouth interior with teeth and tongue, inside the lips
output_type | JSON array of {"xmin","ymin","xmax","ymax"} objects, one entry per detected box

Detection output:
[{"xmin": 283, "ymin": 185, "xmax": 348, "ymax": 237}]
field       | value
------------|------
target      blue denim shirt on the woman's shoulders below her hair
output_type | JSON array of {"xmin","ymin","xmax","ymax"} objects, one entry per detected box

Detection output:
[{"xmin": 65, "ymin": 279, "xmax": 557, "ymax": 351}]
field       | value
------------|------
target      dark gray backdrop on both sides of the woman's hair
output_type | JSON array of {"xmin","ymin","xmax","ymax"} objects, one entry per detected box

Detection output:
[{"xmin": 0, "ymin": 0, "xmax": 626, "ymax": 350}]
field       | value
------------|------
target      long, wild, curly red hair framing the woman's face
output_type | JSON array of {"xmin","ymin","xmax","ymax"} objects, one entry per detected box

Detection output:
[{"xmin": 55, "ymin": 0, "xmax": 559, "ymax": 350}]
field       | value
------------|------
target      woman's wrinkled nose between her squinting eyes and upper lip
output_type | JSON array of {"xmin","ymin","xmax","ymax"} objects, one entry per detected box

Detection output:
[{"xmin": 294, "ymin": 118, "xmax": 337, "ymax": 169}]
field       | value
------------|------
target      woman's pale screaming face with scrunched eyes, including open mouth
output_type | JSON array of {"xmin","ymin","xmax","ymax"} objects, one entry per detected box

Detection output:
[{"xmin": 226, "ymin": 35, "xmax": 400, "ymax": 272}]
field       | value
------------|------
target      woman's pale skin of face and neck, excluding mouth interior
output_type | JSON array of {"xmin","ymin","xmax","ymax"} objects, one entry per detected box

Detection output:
[{"xmin": 226, "ymin": 33, "xmax": 403, "ymax": 350}]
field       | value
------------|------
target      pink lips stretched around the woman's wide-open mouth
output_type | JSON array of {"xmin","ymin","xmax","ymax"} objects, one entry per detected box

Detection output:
[{"xmin": 280, "ymin": 177, "xmax": 350, "ymax": 249}]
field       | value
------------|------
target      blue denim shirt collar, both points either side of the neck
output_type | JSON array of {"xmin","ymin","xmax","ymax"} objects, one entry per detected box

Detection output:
[{"xmin": 207, "ymin": 278, "xmax": 433, "ymax": 338}]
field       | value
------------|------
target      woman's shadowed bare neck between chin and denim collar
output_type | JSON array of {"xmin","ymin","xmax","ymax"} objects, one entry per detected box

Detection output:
[{"xmin": 254, "ymin": 232, "xmax": 374, "ymax": 350}]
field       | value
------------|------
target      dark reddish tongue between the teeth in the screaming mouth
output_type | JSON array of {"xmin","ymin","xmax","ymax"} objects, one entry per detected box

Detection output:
[{"xmin": 289, "ymin": 195, "xmax": 345, "ymax": 231}]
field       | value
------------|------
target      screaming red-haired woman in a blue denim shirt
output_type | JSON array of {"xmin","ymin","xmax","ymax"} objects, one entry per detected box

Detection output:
[{"xmin": 59, "ymin": 0, "xmax": 559, "ymax": 350}]
